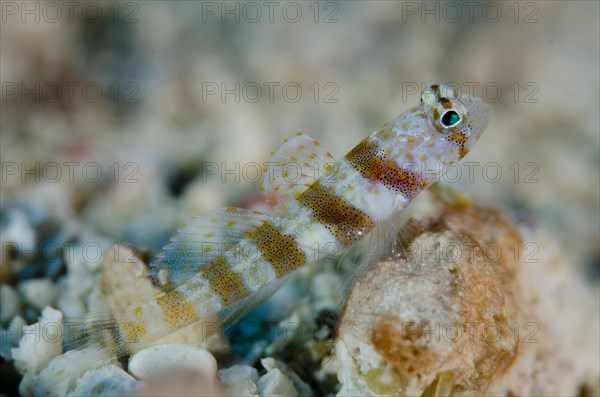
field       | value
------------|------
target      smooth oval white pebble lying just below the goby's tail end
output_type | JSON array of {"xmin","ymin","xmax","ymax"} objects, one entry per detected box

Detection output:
[{"xmin": 129, "ymin": 344, "xmax": 217, "ymax": 380}]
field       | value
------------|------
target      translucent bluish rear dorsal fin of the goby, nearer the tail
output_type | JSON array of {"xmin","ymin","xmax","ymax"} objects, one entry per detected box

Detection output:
[{"xmin": 149, "ymin": 207, "xmax": 269, "ymax": 288}]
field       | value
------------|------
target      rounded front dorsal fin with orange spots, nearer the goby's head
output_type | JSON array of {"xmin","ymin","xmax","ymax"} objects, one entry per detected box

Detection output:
[{"xmin": 262, "ymin": 132, "xmax": 335, "ymax": 207}]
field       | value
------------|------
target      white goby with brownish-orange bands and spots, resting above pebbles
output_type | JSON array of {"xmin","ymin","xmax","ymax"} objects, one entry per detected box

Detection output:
[{"xmin": 74, "ymin": 85, "xmax": 492, "ymax": 354}]
